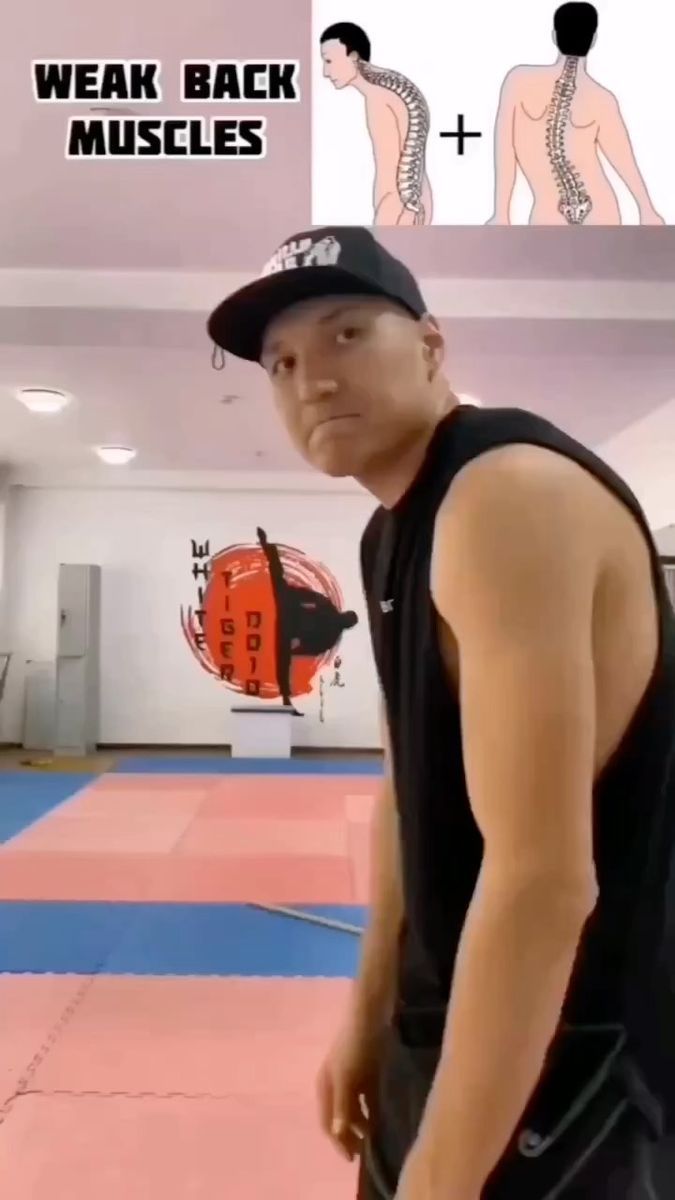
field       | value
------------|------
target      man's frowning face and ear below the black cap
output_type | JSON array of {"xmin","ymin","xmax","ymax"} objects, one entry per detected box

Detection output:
[{"xmin": 261, "ymin": 296, "xmax": 442, "ymax": 479}]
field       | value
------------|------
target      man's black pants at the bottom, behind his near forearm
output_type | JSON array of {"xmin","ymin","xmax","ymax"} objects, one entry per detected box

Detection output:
[{"xmin": 358, "ymin": 1030, "xmax": 662, "ymax": 1200}]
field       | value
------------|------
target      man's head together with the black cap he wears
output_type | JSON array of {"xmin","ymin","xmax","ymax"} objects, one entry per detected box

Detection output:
[{"xmin": 208, "ymin": 227, "xmax": 449, "ymax": 481}]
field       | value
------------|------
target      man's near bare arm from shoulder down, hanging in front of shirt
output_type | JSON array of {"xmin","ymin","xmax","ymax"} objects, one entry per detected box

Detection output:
[{"xmin": 416, "ymin": 446, "xmax": 597, "ymax": 1200}]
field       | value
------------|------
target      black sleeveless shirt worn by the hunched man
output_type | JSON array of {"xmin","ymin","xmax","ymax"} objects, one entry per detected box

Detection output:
[{"xmin": 362, "ymin": 407, "xmax": 675, "ymax": 1104}]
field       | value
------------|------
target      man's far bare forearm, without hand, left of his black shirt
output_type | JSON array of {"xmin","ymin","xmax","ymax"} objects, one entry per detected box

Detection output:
[{"xmin": 345, "ymin": 713, "xmax": 404, "ymax": 1036}]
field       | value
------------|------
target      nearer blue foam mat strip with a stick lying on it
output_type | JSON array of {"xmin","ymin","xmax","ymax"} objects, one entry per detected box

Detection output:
[{"xmin": 0, "ymin": 901, "xmax": 365, "ymax": 979}]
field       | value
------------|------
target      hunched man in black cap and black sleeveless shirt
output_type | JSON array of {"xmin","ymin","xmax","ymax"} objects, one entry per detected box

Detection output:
[{"xmin": 209, "ymin": 228, "xmax": 675, "ymax": 1200}]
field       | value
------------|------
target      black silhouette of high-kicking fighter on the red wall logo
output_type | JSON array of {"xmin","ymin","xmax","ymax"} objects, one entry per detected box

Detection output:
[{"xmin": 257, "ymin": 528, "xmax": 358, "ymax": 707}]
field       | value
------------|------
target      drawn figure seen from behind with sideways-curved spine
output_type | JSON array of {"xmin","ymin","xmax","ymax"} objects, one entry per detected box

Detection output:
[{"xmin": 488, "ymin": 2, "xmax": 664, "ymax": 226}]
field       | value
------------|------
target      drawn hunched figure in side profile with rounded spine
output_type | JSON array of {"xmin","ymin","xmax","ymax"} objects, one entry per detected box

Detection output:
[{"xmin": 321, "ymin": 22, "xmax": 432, "ymax": 226}]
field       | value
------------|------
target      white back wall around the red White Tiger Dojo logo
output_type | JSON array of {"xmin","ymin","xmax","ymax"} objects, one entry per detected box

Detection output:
[{"xmin": 1, "ymin": 487, "xmax": 380, "ymax": 748}]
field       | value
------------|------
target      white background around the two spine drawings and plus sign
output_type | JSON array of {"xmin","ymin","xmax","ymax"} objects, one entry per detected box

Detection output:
[{"xmin": 311, "ymin": 0, "xmax": 675, "ymax": 226}]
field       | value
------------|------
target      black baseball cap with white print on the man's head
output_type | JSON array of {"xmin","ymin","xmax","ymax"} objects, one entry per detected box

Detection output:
[{"xmin": 207, "ymin": 226, "xmax": 426, "ymax": 362}]
